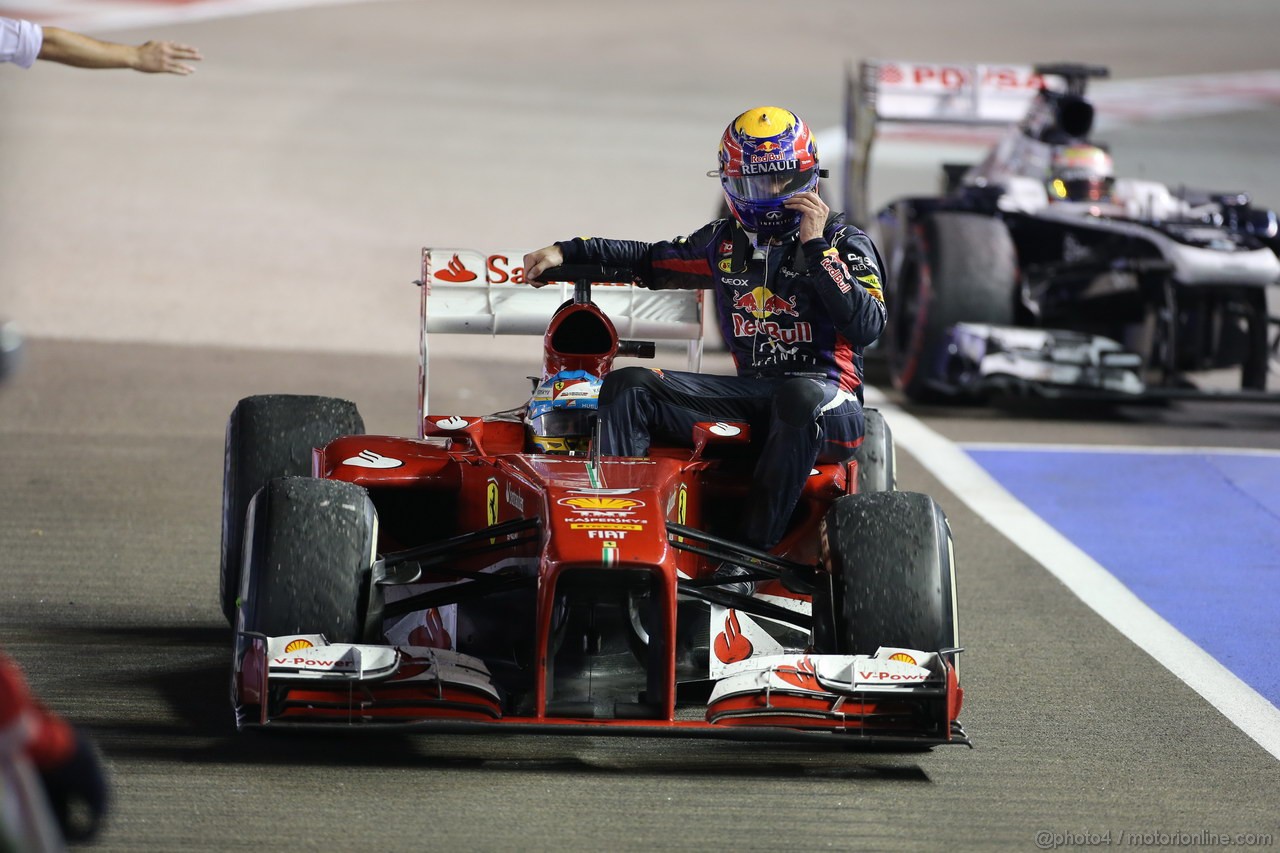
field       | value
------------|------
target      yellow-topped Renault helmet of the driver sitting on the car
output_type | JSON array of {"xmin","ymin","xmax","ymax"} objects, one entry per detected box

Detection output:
[{"xmin": 719, "ymin": 106, "xmax": 818, "ymax": 237}]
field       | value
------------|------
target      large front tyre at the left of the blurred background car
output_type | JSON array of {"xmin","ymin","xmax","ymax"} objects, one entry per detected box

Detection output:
[{"xmin": 886, "ymin": 211, "xmax": 1018, "ymax": 402}]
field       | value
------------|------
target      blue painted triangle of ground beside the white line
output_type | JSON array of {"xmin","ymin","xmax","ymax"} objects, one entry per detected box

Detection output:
[{"xmin": 964, "ymin": 446, "xmax": 1280, "ymax": 706}]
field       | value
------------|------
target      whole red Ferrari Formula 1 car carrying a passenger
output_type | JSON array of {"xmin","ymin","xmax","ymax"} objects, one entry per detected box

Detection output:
[{"xmin": 221, "ymin": 248, "xmax": 969, "ymax": 749}]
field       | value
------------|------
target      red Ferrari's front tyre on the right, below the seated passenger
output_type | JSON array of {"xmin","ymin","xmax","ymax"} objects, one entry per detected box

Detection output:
[{"xmin": 814, "ymin": 492, "xmax": 957, "ymax": 654}]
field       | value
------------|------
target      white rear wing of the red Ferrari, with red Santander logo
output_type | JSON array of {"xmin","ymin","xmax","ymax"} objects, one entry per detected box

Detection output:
[{"xmin": 417, "ymin": 247, "xmax": 703, "ymax": 418}]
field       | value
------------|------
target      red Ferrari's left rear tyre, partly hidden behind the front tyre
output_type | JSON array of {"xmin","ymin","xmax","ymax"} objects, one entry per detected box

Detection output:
[{"xmin": 219, "ymin": 394, "xmax": 365, "ymax": 622}]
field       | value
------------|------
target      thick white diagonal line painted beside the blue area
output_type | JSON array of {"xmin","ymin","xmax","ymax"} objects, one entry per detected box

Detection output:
[{"xmin": 867, "ymin": 388, "xmax": 1280, "ymax": 758}]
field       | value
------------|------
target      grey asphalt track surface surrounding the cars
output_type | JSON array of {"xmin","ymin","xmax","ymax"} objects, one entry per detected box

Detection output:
[{"xmin": 0, "ymin": 1, "xmax": 1280, "ymax": 850}]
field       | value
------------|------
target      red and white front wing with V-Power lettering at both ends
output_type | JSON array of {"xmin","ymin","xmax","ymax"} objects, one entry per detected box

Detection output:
[{"xmin": 233, "ymin": 634, "xmax": 969, "ymax": 747}]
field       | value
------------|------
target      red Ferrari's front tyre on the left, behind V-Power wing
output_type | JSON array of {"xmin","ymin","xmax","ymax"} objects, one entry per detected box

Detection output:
[{"xmin": 237, "ymin": 476, "xmax": 381, "ymax": 643}]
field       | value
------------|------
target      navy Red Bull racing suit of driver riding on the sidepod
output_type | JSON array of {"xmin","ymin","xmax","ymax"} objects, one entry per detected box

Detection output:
[{"xmin": 558, "ymin": 214, "xmax": 884, "ymax": 549}]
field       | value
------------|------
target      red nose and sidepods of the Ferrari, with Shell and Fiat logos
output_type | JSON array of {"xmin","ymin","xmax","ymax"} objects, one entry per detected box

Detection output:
[{"xmin": 303, "ymin": 427, "xmax": 858, "ymax": 722}]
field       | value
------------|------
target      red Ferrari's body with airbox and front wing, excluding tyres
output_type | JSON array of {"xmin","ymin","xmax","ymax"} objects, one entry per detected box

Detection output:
[{"xmin": 236, "ymin": 256, "xmax": 964, "ymax": 744}]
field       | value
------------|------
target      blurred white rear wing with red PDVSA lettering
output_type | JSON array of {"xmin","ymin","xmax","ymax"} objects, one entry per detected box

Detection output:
[{"xmin": 845, "ymin": 59, "xmax": 1046, "ymax": 224}]
